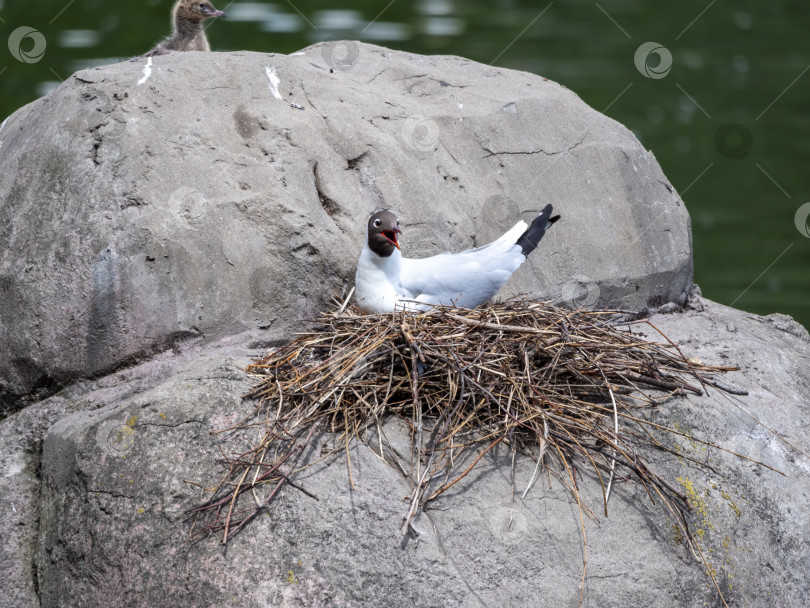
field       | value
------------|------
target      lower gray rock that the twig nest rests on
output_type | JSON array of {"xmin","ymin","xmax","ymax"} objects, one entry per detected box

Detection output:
[{"xmin": 0, "ymin": 300, "xmax": 810, "ymax": 608}]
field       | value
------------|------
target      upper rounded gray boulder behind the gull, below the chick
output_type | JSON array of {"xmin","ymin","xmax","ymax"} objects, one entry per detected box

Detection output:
[{"xmin": 0, "ymin": 43, "xmax": 692, "ymax": 407}]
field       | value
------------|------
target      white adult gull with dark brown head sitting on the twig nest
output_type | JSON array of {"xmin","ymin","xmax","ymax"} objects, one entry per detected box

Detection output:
[{"xmin": 354, "ymin": 205, "xmax": 560, "ymax": 314}]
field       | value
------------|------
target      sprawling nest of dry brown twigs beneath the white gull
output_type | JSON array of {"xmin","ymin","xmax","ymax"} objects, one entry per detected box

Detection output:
[{"xmin": 188, "ymin": 301, "xmax": 745, "ymax": 580}]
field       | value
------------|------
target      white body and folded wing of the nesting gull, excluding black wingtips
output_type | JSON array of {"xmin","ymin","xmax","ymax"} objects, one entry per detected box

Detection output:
[{"xmin": 399, "ymin": 221, "xmax": 527, "ymax": 308}]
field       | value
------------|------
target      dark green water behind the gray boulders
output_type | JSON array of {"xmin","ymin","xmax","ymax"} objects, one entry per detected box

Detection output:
[{"xmin": 0, "ymin": 0, "xmax": 810, "ymax": 326}]
